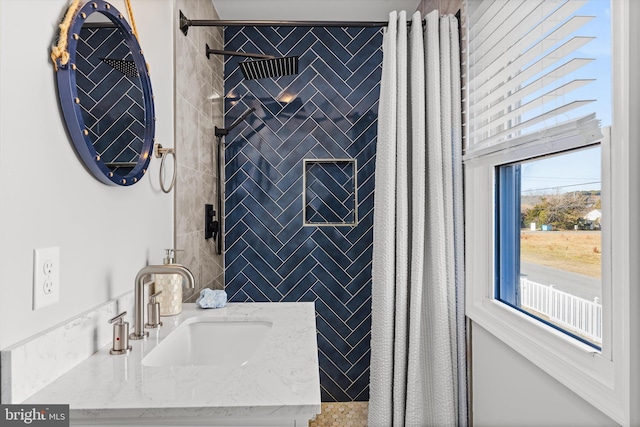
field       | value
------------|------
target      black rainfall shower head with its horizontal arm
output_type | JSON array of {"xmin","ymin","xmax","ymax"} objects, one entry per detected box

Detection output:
[{"xmin": 206, "ymin": 44, "xmax": 298, "ymax": 80}]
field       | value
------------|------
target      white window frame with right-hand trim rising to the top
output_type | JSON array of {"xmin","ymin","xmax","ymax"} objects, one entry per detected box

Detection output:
[{"xmin": 464, "ymin": 0, "xmax": 640, "ymax": 426}]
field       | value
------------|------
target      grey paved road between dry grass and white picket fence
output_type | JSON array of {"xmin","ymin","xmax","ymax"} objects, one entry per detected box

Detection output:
[{"xmin": 520, "ymin": 261, "xmax": 602, "ymax": 301}]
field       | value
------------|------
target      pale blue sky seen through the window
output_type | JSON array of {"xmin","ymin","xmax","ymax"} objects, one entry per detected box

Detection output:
[{"xmin": 521, "ymin": 0, "xmax": 612, "ymax": 195}]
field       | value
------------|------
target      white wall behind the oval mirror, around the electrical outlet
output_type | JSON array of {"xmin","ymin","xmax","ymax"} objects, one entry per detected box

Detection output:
[{"xmin": 0, "ymin": 0, "xmax": 174, "ymax": 349}]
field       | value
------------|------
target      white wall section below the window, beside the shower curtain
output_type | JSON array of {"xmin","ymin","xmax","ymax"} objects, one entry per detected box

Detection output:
[{"xmin": 471, "ymin": 323, "xmax": 618, "ymax": 427}]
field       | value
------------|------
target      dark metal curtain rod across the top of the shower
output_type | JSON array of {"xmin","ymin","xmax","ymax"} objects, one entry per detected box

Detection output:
[{"xmin": 180, "ymin": 11, "xmax": 425, "ymax": 36}]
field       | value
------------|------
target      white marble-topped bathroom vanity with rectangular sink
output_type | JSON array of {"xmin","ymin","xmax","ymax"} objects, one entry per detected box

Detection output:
[{"xmin": 24, "ymin": 303, "xmax": 320, "ymax": 427}]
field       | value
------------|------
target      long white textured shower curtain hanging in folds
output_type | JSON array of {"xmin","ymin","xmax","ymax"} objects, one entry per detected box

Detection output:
[{"xmin": 369, "ymin": 11, "xmax": 467, "ymax": 427}]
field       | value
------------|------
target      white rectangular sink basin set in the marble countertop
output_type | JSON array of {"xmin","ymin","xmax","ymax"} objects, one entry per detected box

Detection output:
[{"xmin": 142, "ymin": 316, "xmax": 273, "ymax": 367}]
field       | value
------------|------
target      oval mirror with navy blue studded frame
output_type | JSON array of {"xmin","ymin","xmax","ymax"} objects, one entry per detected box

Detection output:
[{"xmin": 56, "ymin": 0, "xmax": 155, "ymax": 186}]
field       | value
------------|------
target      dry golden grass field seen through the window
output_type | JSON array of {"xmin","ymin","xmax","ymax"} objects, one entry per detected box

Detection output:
[{"xmin": 520, "ymin": 231, "xmax": 602, "ymax": 277}]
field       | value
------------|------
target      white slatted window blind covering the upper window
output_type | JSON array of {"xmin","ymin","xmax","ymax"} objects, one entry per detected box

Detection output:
[{"xmin": 464, "ymin": 0, "xmax": 595, "ymax": 154}]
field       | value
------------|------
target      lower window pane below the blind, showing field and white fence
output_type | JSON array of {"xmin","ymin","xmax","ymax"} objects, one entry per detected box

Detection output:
[{"xmin": 495, "ymin": 146, "xmax": 603, "ymax": 350}]
